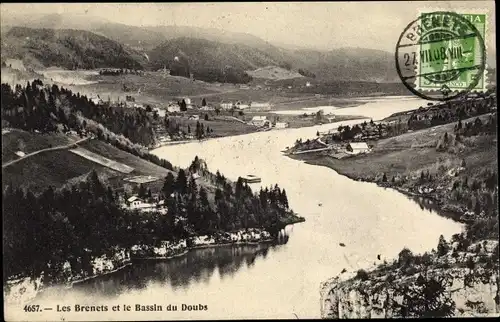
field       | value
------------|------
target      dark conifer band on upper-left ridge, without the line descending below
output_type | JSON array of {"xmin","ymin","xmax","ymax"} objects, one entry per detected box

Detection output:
[{"xmin": 1, "ymin": 80, "xmax": 155, "ymax": 146}]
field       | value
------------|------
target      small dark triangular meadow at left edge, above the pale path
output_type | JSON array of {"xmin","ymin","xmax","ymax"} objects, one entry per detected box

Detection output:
[{"xmin": 2, "ymin": 129, "xmax": 78, "ymax": 163}]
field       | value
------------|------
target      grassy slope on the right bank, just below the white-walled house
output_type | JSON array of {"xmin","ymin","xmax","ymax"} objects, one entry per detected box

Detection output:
[{"xmin": 293, "ymin": 115, "xmax": 497, "ymax": 184}]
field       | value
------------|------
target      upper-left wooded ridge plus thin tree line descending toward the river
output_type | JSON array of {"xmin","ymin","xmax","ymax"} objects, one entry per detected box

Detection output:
[{"xmin": 1, "ymin": 80, "xmax": 172, "ymax": 169}]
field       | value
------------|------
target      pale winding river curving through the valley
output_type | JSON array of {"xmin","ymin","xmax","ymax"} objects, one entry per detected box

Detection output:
[{"xmin": 21, "ymin": 98, "xmax": 462, "ymax": 320}]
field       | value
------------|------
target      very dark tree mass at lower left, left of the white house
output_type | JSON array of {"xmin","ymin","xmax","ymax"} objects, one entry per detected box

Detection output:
[{"xmin": 2, "ymin": 172, "xmax": 133, "ymax": 280}]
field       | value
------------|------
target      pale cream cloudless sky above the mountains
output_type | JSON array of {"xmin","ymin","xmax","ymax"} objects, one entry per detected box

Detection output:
[{"xmin": 0, "ymin": 1, "xmax": 495, "ymax": 51}]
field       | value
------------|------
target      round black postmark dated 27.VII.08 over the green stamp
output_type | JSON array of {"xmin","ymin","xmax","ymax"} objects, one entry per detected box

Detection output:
[{"xmin": 395, "ymin": 11, "xmax": 486, "ymax": 101}]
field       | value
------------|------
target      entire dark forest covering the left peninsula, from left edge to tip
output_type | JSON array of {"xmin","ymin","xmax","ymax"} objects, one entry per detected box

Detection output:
[{"xmin": 2, "ymin": 158, "xmax": 293, "ymax": 281}]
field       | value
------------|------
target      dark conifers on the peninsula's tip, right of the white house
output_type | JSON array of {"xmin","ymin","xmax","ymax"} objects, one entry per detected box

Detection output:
[{"xmin": 162, "ymin": 167, "xmax": 291, "ymax": 237}]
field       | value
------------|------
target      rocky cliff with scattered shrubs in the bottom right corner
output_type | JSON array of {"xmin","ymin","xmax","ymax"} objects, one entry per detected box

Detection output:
[{"xmin": 320, "ymin": 240, "xmax": 500, "ymax": 319}]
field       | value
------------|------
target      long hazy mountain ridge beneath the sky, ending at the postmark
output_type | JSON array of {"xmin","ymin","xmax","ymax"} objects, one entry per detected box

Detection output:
[{"xmin": 2, "ymin": 14, "xmax": 478, "ymax": 82}]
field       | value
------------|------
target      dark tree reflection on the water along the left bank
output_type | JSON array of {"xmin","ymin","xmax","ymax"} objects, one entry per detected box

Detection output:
[{"xmin": 69, "ymin": 230, "xmax": 289, "ymax": 298}]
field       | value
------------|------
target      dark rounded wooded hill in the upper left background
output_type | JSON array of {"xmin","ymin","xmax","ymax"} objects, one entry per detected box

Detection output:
[{"xmin": 1, "ymin": 27, "xmax": 145, "ymax": 69}]
